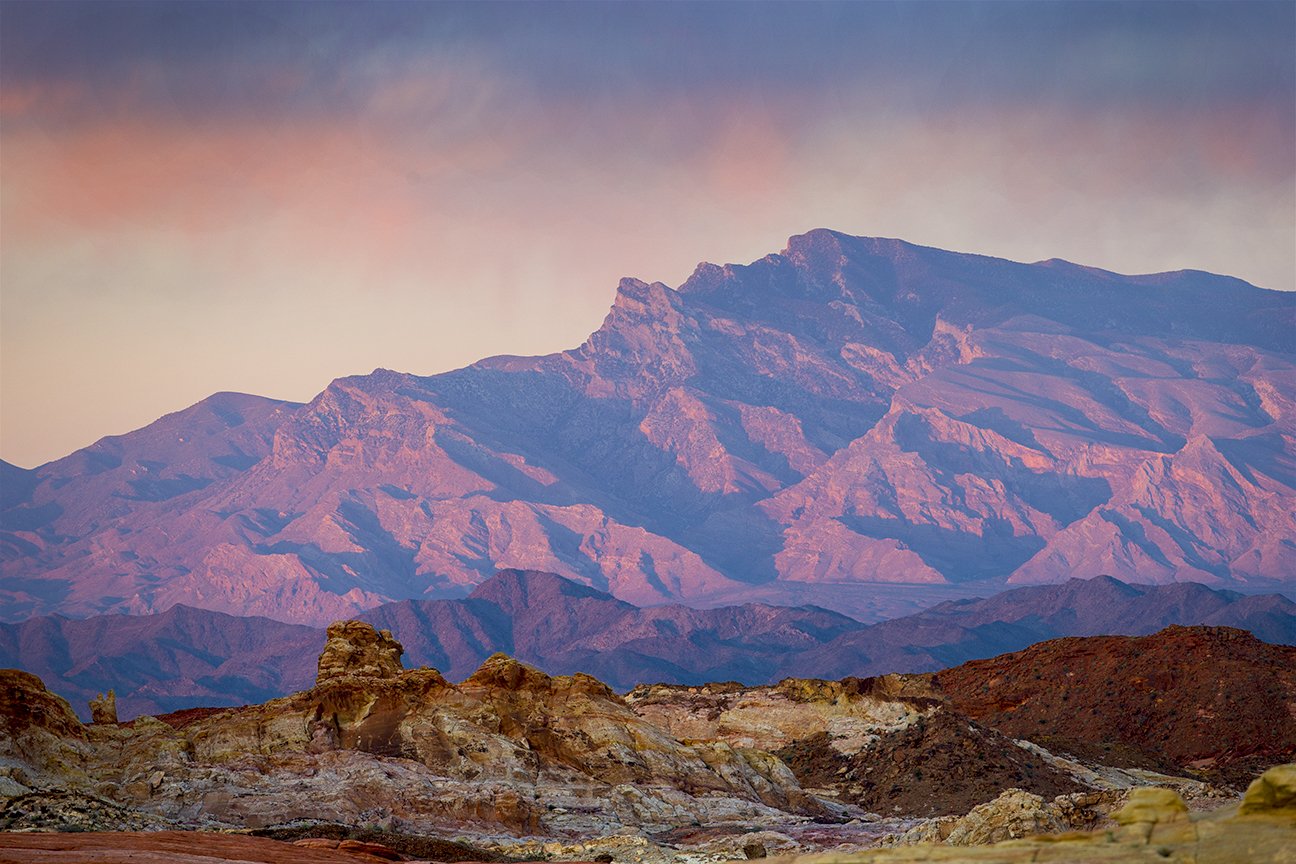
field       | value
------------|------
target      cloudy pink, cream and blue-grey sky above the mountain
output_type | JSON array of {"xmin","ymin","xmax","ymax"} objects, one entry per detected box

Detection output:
[{"xmin": 0, "ymin": 3, "xmax": 1296, "ymax": 466}]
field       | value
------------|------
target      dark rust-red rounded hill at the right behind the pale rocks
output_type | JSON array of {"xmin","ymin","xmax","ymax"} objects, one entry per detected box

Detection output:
[{"xmin": 933, "ymin": 627, "xmax": 1296, "ymax": 782}]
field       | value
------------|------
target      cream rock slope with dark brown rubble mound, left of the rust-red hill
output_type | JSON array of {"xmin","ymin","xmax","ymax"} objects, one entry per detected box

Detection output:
[{"xmin": 626, "ymin": 675, "xmax": 1083, "ymax": 816}]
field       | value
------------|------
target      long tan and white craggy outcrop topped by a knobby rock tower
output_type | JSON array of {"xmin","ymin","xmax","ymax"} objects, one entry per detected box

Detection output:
[{"xmin": 0, "ymin": 639, "xmax": 841, "ymax": 836}]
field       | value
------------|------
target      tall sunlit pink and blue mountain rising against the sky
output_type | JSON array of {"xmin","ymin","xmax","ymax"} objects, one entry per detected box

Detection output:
[{"xmin": 0, "ymin": 231, "xmax": 1296, "ymax": 623}]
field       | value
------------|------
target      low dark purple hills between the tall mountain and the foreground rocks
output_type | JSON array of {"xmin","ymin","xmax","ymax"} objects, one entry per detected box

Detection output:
[{"xmin": 0, "ymin": 570, "xmax": 1296, "ymax": 716}]
